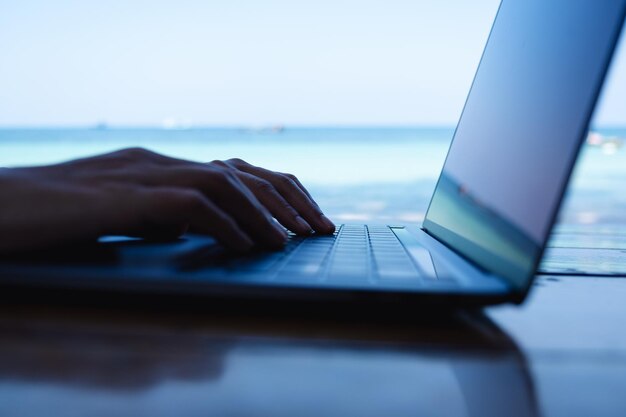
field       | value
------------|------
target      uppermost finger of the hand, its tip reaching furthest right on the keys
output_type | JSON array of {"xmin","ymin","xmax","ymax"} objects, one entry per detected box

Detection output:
[{"xmin": 227, "ymin": 159, "xmax": 335, "ymax": 233}]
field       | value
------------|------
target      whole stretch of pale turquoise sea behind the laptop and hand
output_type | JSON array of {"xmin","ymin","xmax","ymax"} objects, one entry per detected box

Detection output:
[{"xmin": 0, "ymin": 128, "xmax": 626, "ymax": 226}]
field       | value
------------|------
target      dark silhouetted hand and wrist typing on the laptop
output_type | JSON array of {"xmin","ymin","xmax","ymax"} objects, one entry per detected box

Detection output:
[{"xmin": 0, "ymin": 148, "xmax": 335, "ymax": 253}]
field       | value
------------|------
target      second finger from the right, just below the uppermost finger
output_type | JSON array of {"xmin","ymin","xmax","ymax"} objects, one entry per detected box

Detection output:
[{"xmin": 237, "ymin": 171, "xmax": 313, "ymax": 235}]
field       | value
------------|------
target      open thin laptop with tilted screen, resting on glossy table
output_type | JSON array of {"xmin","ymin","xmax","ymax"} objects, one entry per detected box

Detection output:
[{"xmin": 0, "ymin": 0, "xmax": 626, "ymax": 311}]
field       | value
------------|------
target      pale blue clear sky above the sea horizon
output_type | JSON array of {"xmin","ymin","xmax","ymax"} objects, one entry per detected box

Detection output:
[{"xmin": 0, "ymin": 0, "xmax": 626, "ymax": 126}]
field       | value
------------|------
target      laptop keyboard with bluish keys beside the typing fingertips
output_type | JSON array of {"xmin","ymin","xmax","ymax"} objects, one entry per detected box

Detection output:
[{"xmin": 233, "ymin": 225, "xmax": 421, "ymax": 283}]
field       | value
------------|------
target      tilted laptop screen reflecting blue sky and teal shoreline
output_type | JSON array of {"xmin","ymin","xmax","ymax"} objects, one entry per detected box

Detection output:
[{"xmin": 424, "ymin": 0, "xmax": 626, "ymax": 290}]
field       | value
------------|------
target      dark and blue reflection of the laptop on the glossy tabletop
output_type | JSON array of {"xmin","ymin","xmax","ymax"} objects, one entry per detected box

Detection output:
[{"xmin": 0, "ymin": 307, "xmax": 539, "ymax": 416}]
